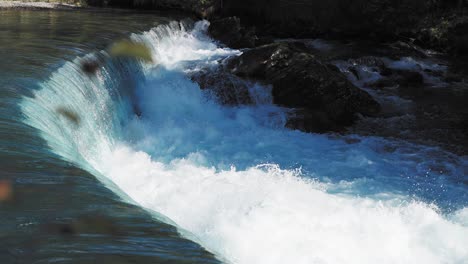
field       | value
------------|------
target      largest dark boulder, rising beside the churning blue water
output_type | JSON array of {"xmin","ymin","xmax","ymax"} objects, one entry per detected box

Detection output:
[{"xmin": 227, "ymin": 43, "xmax": 380, "ymax": 131}]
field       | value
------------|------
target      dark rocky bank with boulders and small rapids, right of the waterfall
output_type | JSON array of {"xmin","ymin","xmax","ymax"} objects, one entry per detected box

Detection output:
[{"xmin": 200, "ymin": 17, "xmax": 468, "ymax": 155}]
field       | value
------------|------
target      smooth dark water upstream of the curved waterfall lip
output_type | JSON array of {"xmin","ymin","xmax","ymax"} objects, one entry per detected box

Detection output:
[{"xmin": 0, "ymin": 11, "xmax": 217, "ymax": 264}]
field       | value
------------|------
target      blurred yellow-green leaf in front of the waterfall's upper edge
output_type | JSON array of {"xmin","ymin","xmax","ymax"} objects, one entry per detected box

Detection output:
[{"xmin": 109, "ymin": 40, "xmax": 153, "ymax": 63}]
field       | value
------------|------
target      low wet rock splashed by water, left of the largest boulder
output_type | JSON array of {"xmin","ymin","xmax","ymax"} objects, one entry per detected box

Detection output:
[{"xmin": 191, "ymin": 69, "xmax": 252, "ymax": 105}]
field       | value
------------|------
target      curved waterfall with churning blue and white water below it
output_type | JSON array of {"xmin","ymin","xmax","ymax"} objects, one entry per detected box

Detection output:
[{"xmin": 21, "ymin": 21, "xmax": 468, "ymax": 264}]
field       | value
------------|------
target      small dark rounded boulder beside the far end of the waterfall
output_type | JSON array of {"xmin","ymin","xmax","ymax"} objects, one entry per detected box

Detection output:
[{"xmin": 208, "ymin": 17, "xmax": 256, "ymax": 49}]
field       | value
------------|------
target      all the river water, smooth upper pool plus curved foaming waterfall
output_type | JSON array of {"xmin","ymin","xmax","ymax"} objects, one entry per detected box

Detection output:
[{"xmin": 0, "ymin": 8, "xmax": 468, "ymax": 264}]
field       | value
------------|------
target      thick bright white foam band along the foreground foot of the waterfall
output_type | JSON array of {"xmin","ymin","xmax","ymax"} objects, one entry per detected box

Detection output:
[{"xmin": 94, "ymin": 146, "xmax": 468, "ymax": 263}]
